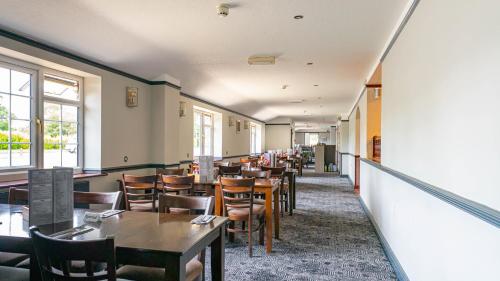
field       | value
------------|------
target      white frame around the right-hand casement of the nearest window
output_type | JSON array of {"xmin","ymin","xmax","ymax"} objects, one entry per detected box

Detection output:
[{"xmin": 39, "ymin": 69, "xmax": 84, "ymax": 173}]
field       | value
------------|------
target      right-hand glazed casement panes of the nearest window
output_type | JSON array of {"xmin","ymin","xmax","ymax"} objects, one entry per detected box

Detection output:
[{"xmin": 43, "ymin": 74, "xmax": 81, "ymax": 168}]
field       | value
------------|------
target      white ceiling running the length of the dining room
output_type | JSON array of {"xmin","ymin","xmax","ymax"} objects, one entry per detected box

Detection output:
[{"xmin": 0, "ymin": 0, "xmax": 408, "ymax": 122}]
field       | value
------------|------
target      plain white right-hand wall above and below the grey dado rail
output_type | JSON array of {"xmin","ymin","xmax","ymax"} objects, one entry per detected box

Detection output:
[{"xmin": 349, "ymin": 0, "xmax": 500, "ymax": 281}]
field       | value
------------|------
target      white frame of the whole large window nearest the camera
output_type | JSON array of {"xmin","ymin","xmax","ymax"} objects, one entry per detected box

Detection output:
[{"xmin": 0, "ymin": 54, "xmax": 85, "ymax": 175}]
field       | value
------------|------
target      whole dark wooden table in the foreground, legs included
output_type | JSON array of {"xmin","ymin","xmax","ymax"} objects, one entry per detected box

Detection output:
[{"xmin": 0, "ymin": 204, "xmax": 227, "ymax": 280}]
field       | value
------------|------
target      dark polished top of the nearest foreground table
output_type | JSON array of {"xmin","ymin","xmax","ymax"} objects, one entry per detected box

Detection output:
[{"xmin": 0, "ymin": 204, "xmax": 227, "ymax": 255}]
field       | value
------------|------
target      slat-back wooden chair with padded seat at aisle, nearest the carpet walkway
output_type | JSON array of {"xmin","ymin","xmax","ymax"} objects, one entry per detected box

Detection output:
[{"xmin": 217, "ymin": 177, "xmax": 266, "ymax": 257}]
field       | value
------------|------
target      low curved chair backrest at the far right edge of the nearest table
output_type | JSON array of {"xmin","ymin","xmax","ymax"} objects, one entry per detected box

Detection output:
[{"xmin": 158, "ymin": 194, "xmax": 215, "ymax": 215}]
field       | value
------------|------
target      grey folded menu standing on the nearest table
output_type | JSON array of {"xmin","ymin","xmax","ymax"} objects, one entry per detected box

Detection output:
[{"xmin": 28, "ymin": 168, "xmax": 73, "ymax": 226}]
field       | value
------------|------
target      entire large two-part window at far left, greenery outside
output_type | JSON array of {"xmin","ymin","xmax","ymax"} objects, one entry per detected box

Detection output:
[{"xmin": 0, "ymin": 58, "xmax": 83, "ymax": 170}]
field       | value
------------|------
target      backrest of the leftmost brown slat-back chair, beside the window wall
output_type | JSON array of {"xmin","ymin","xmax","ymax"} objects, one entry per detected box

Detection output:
[{"xmin": 120, "ymin": 174, "xmax": 158, "ymax": 211}]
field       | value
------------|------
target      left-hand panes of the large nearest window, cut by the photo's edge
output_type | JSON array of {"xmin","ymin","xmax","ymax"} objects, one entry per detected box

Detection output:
[{"xmin": 0, "ymin": 63, "xmax": 36, "ymax": 169}]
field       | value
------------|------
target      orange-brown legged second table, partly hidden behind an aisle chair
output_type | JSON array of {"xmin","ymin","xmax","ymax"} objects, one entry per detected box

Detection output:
[{"xmin": 194, "ymin": 174, "xmax": 280, "ymax": 254}]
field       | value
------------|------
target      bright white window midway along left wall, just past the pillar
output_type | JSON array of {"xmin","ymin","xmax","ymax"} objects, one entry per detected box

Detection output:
[{"xmin": 193, "ymin": 110, "xmax": 214, "ymax": 157}]
